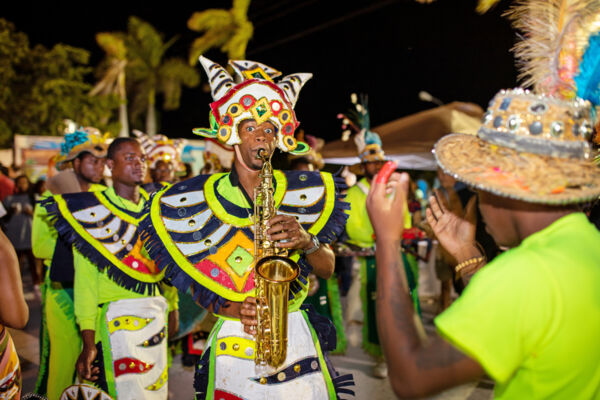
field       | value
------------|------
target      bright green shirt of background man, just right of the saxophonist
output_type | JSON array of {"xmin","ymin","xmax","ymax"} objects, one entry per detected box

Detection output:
[{"xmin": 345, "ymin": 178, "xmax": 412, "ymax": 248}]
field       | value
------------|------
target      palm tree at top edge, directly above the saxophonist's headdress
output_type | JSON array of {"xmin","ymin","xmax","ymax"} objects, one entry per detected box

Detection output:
[{"xmin": 188, "ymin": 0, "xmax": 254, "ymax": 65}]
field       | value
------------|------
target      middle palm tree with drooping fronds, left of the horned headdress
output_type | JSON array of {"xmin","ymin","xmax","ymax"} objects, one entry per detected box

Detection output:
[{"xmin": 125, "ymin": 17, "xmax": 200, "ymax": 136}]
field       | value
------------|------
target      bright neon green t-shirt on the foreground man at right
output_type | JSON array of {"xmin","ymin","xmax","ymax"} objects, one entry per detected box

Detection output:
[{"xmin": 435, "ymin": 213, "xmax": 600, "ymax": 400}]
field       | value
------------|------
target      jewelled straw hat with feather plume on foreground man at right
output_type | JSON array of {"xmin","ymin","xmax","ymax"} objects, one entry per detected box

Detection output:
[{"xmin": 435, "ymin": 0, "xmax": 600, "ymax": 204}]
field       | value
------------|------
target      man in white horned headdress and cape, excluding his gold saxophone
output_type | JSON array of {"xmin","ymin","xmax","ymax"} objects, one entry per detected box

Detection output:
[{"xmin": 143, "ymin": 57, "xmax": 353, "ymax": 399}]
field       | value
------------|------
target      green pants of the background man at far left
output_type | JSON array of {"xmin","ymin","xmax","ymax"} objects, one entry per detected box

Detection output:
[{"xmin": 38, "ymin": 280, "xmax": 82, "ymax": 400}]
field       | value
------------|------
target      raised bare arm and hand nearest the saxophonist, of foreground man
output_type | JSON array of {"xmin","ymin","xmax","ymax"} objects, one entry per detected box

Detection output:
[{"xmin": 367, "ymin": 170, "xmax": 483, "ymax": 397}]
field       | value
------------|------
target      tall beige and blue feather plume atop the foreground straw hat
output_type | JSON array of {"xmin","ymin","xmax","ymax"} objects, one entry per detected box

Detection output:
[{"xmin": 506, "ymin": 0, "xmax": 600, "ymax": 106}]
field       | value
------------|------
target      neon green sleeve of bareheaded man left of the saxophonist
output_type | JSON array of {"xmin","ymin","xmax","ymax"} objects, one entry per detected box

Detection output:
[{"xmin": 73, "ymin": 248, "xmax": 100, "ymax": 331}]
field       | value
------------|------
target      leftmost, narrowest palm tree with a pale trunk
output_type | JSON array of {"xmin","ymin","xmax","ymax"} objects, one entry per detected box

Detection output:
[{"xmin": 90, "ymin": 32, "xmax": 129, "ymax": 136}]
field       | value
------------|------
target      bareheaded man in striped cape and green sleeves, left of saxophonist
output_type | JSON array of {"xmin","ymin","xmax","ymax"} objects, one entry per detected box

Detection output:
[{"xmin": 44, "ymin": 138, "xmax": 176, "ymax": 399}]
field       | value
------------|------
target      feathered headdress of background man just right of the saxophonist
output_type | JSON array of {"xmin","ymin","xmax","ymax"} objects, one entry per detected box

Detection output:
[{"xmin": 337, "ymin": 93, "xmax": 385, "ymax": 163}]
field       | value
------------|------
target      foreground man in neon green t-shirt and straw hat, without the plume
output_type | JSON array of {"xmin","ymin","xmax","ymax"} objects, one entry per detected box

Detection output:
[{"xmin": 367, "ymin": 84, "xmax": 600, "ymax": 399}]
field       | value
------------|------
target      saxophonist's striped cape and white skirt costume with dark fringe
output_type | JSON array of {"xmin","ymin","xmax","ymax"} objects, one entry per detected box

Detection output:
[{"xmin": 142, "ymin": 166, "xmax": 352, "ymax": 399}]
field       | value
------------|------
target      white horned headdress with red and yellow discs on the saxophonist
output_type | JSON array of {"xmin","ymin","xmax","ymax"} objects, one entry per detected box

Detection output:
[{"xmin": 194, "ymin": 56, "xmax": 312, "ymax": 154}]
